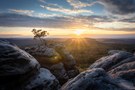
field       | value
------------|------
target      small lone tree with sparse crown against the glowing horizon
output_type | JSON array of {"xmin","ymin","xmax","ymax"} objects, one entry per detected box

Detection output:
[{"xmin": 31, "ymin": 29, "xmax": 49, "ymax": 46}]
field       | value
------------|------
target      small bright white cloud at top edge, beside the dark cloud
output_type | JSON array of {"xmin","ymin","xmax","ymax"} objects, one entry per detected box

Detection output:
[{"xmin": 67, "ymin": 0, "xmax": 97, "ymax": 9}]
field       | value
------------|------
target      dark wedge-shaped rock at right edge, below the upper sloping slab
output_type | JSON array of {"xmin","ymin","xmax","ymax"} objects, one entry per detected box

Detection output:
[{"xmin": 108, "ymin": 59, "xmax": 135, "ymax": 84}]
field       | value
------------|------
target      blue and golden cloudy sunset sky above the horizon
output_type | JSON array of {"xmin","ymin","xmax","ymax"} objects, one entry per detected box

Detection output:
[{"xmin": 0, "ymin": 0, "xmax": 135, "ymax": 38}]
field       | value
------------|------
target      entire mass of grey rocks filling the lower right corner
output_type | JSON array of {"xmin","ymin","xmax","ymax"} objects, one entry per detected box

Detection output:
[{"xmin": 61, "ymin": 50, "xmax": 135, "ymax": 90}]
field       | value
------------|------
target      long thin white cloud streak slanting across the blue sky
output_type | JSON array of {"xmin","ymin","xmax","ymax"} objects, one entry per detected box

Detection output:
[{"xmin": 40, "ymin": 4, "xmax": 93, "ymax": 14}]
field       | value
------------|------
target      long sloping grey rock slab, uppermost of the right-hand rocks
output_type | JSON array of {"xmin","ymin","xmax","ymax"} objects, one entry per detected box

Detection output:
[{"xmin": 89, "ymin": 51, "xmax": 133, "ymax": 71}]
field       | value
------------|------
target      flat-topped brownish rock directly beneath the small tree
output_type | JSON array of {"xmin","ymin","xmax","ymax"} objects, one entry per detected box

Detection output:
[{"xmin": 25, "ymin": 46, "xmax": 61, "ymax": 65}]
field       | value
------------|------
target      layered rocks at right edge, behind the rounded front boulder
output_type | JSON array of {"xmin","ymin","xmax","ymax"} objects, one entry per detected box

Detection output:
[{"xmin": 89, "ymin": 50, "xmax": 135, "ymax": 90}]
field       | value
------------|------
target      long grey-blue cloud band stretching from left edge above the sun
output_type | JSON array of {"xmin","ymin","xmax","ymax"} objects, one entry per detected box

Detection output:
[{"xmin": 0, "ymin": 13, "xmax": 111, "ymax": 28}]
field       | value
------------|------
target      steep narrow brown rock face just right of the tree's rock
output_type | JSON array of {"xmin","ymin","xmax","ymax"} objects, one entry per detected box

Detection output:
[{"xmin": 55, "ymin": 44, "xmax": 79, "ymax": 78}]
